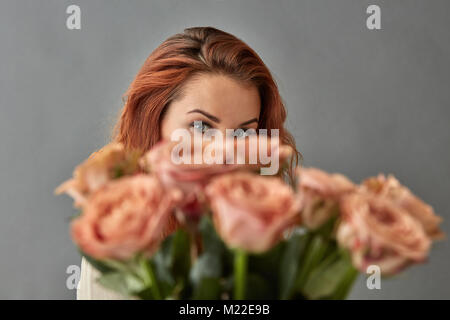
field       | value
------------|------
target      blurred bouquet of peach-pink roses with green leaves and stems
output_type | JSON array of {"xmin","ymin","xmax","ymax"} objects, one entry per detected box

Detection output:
[{"xmin": 57, "ymin": 142, "xmax": 443, "ymax": 299}]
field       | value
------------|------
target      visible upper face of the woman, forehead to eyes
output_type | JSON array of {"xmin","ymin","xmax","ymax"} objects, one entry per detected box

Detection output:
[{"xmin": 161, "ymin": 74, "xmax": 261, "ymax": 140}]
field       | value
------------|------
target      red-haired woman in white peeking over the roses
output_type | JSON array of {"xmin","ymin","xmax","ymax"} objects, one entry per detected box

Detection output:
[{"xmin": 77, "ymin": 27, "xmax": 299, "ymax": 299}]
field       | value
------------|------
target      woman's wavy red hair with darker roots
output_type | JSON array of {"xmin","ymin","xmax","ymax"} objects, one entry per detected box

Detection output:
[{"xmin": 114, "ymin": 27, "xmax": 299, "ymax": 182}]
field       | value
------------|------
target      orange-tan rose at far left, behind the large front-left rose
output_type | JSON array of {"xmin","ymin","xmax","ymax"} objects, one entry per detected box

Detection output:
[{"xmin": 55, "ymin": 143, "xmax": 140, "ymax": 207}]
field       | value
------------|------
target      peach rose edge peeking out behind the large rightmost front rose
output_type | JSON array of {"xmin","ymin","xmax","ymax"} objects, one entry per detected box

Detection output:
[{"xmin": 361, "ymin": 174, "xmax": 444, "ymax": 239}]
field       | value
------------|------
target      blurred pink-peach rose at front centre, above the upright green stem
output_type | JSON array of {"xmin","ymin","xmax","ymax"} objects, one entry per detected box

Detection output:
[{"xmin": 206, "ymin": 172, "xmax": 300, "ymax": 253}]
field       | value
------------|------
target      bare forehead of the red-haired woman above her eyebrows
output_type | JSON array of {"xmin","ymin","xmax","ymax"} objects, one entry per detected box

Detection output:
[{"xmin": 178, "ymin": 74, "xmax": 261, "ymax": 123}]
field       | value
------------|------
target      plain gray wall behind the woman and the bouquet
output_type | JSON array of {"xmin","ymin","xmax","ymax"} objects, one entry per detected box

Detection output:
[{"xmin": 0, "ymin": 0, "xmax": 450, "ymax": 299}]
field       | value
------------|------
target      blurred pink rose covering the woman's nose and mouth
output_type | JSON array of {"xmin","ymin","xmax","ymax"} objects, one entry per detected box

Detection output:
[{"xmin": 140, "ymin": 137, "xmax": 292, "ymax": 217}]
